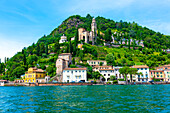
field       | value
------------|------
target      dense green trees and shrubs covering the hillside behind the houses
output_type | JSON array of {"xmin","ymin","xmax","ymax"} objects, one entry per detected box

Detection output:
[{"xmin": 0, "ymin": 14, "xmax": 170, "ymax": 80}]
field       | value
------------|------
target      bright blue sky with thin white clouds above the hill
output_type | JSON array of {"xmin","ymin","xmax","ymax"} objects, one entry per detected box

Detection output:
[{"xmin": 0, "ymin": 0, "xmax": 170, "ymax": 61}]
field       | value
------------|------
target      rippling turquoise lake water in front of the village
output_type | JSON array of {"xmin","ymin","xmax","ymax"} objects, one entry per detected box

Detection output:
[{"xmin": 0, "ymin": 85, "xmax": 170, "ymax": 113}]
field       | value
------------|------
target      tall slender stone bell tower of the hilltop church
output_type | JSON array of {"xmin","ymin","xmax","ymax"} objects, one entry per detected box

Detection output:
[{"xmin": 91, "ymin": 18, "xmax": 97, "ymax": 45}]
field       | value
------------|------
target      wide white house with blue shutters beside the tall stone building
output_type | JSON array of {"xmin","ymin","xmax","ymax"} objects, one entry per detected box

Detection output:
[{"xmin": 63, "ymin": 68, "xmax": 87, "ymax": 82}]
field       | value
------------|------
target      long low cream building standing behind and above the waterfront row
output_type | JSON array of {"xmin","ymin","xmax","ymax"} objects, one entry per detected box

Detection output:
[{"xmin": 87, "ymin": 60, "xmax": 107, "ymax": 66}]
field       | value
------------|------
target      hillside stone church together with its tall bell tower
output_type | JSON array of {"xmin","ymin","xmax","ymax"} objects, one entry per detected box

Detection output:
[{"xmin": 78, "ymin": 18, "xmax": 97, "ymax": 45}]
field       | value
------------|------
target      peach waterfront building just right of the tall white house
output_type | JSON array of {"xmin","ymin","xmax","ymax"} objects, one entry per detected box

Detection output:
[{"xmin": 149, "ymin": 70, "xmax": 165, "ymax": 81}]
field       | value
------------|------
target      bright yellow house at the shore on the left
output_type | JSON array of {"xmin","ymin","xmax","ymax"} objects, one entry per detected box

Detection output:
[{"xmin": 24, "ymin": 68, "xmax": 46, "ymax": 83}]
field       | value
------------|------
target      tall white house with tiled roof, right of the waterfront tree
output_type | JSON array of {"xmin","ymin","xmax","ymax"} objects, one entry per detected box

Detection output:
[{"xmin": 131, "ymin": 65, "xmax": 150, "ymax": 82}]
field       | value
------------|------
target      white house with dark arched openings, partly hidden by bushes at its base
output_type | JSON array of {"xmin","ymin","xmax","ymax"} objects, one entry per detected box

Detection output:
[{"xmin": 99, "ymin": 69, "xmax": 114, "ymax": 82}]
